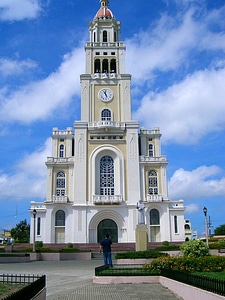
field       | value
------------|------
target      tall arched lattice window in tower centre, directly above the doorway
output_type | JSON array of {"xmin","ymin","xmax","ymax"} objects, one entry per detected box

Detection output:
[{"xmin": 100, "ymin": 155, "xmax": 114, "ymax": 195}]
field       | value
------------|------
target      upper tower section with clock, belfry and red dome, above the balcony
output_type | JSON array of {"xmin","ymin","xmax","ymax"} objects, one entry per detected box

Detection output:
[{"xmin": 80, "ymin": 0, "xmax": 131, "ymax": 122}]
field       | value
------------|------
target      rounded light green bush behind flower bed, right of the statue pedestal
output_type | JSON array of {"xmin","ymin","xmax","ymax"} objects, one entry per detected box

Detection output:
[{"xmin": 180, "ymin": 240, "xmax": 209, "ymax": 257}]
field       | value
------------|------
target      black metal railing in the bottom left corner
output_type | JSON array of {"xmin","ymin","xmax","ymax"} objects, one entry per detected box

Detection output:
[{"xmin": 0, "ymin": 274, "xmax": 46, "ymax": 300}]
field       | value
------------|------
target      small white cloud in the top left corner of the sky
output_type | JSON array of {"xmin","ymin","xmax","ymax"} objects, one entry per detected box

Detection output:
[{"xmin": 0, "ymin": 0, "xmax": 41, "ymax": 21}]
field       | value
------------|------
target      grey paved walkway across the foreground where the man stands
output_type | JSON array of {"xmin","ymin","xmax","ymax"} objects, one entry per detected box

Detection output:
[{"xmin": 0, "ymin": 260, "xmax": 181, "ymax": 300}]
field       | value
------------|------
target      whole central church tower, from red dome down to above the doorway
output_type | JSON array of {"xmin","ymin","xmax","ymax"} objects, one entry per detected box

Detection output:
[{"xmin": 74, "ymin": 0, "xmax": 140, "ymax": 205}]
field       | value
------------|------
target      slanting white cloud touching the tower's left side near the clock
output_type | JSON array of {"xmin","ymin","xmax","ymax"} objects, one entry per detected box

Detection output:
[{"xmin": 0, "ymin": 48, "xmax": 84, "ymax": 123}]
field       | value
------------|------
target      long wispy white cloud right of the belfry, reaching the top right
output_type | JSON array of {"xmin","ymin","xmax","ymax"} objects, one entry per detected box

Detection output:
[{"xmin": 126, "ymin": 7, "xmax": 225, "ymax": 85}]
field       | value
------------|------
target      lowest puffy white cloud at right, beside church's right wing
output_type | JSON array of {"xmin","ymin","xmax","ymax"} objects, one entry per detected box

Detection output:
[{"xmin": 168, "ymin": 166, "xmax": 225, "ymax": 201}]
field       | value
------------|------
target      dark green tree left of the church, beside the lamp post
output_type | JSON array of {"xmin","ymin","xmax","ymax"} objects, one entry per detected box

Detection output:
[{"xmin": 10, "ymin": 219, "xmax": 30, "ymax": 243}]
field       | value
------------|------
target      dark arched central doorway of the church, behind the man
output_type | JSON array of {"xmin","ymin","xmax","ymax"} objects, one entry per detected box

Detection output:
[{"xmin": 97, "ymin": 219, "xmax": 118, "ymax": 243}]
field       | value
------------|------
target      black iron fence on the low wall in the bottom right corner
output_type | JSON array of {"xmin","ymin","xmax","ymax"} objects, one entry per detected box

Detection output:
[{"xmin": 161, "ymin": 270, "xmax": 225, "ymax": 296}]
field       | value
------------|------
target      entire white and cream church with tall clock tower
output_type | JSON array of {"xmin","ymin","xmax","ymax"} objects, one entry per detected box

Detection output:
[{"xmin": 30, "ymin": 0, "xmax": 185, "ymax": 243}]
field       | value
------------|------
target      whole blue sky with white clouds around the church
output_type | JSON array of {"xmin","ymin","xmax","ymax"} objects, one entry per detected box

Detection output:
[{"xmin": 0, "ymin": 0, "xmax": 225, "ymax": 235}]
